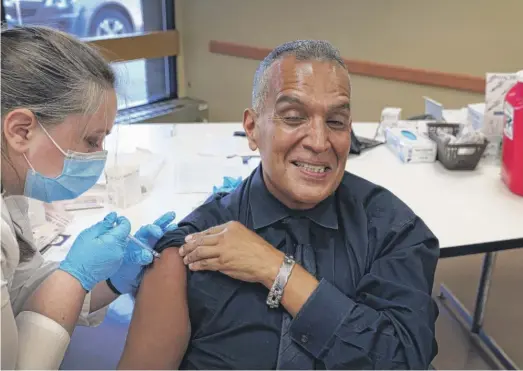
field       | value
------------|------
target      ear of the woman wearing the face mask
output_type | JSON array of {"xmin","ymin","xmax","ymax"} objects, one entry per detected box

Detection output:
[{"xmin": 2, "ymin": 109, "xmax": 38, "ymax": 154}]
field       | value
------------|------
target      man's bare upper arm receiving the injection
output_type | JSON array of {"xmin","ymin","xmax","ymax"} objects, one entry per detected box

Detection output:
[{"xmin": 118, "ymin": 248, "xmax": 190, "ymax": 370}]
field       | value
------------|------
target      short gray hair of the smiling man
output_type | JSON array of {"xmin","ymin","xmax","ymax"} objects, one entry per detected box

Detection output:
[{"xmin": 252, "ymin": 40, "xmax": 347, "ymax": 111}]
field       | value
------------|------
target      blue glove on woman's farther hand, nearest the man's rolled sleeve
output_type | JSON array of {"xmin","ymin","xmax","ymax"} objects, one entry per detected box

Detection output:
[{"xmin": 107, "ymin": 212, "xmax": 177, "ymax": 294}]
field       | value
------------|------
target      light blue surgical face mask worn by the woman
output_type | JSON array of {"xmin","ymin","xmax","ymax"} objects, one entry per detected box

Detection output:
[{"xmin": 24, "ymin": 124, "xmax": 107, "ymax": 202}]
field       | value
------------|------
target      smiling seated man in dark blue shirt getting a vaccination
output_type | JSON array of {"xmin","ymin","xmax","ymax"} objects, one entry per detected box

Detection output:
[{"xmin": 117, "ymin": 41, "xmax": 439, "ymax": 369}]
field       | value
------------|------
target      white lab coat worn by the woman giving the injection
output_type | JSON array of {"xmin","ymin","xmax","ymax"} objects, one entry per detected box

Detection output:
[{"xmin": 0, "ymin": 197, "xmax": 106, "ymax": 370}]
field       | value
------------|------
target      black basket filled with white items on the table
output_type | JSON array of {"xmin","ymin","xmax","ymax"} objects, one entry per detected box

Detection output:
[{"xmin": 427, "ymin": 123, "xmax": 488, "ymax": 170}]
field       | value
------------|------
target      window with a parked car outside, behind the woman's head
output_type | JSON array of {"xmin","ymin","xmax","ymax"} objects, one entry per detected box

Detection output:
[{"xmin": 2, "ymin": 0, "xmax": 178, "ymax": 116}]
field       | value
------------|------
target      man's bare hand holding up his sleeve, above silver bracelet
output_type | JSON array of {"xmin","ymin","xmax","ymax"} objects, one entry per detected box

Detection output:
[{"xmin": 179, "ymin": 221, "xmax": 284, "ymax": 287}]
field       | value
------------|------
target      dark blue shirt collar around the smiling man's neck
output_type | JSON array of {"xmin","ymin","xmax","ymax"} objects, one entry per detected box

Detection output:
[{"xmin": 249, "ymin": 165, "xmax": 338, "ymax": 229}]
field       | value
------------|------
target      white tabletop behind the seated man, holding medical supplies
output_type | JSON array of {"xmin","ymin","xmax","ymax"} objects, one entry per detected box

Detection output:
[{"xmin": 44, "ymin": 123, "xmax": 523, "ymax": 259}]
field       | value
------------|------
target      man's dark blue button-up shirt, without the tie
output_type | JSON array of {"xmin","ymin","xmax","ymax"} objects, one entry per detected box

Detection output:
[{"xmin": 156, "ymin": 167, "xmax": 439, "ymax": 369}]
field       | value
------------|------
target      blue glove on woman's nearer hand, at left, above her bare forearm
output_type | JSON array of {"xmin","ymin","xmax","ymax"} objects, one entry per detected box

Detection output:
[{"xmin": 59, "ymin": 213, "xmax": 131, "ymax": 291}]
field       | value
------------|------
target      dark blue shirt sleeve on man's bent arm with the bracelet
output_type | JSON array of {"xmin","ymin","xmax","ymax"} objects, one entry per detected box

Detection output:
[{"xmin": 290, "ymin": 217, "xmax": 439, "ymax": 369}]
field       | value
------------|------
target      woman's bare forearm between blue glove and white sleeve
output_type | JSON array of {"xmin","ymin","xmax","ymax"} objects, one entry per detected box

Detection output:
[{"xmin": 24, "ymin": 270, "xmax": 87, "ymax": 335}]
